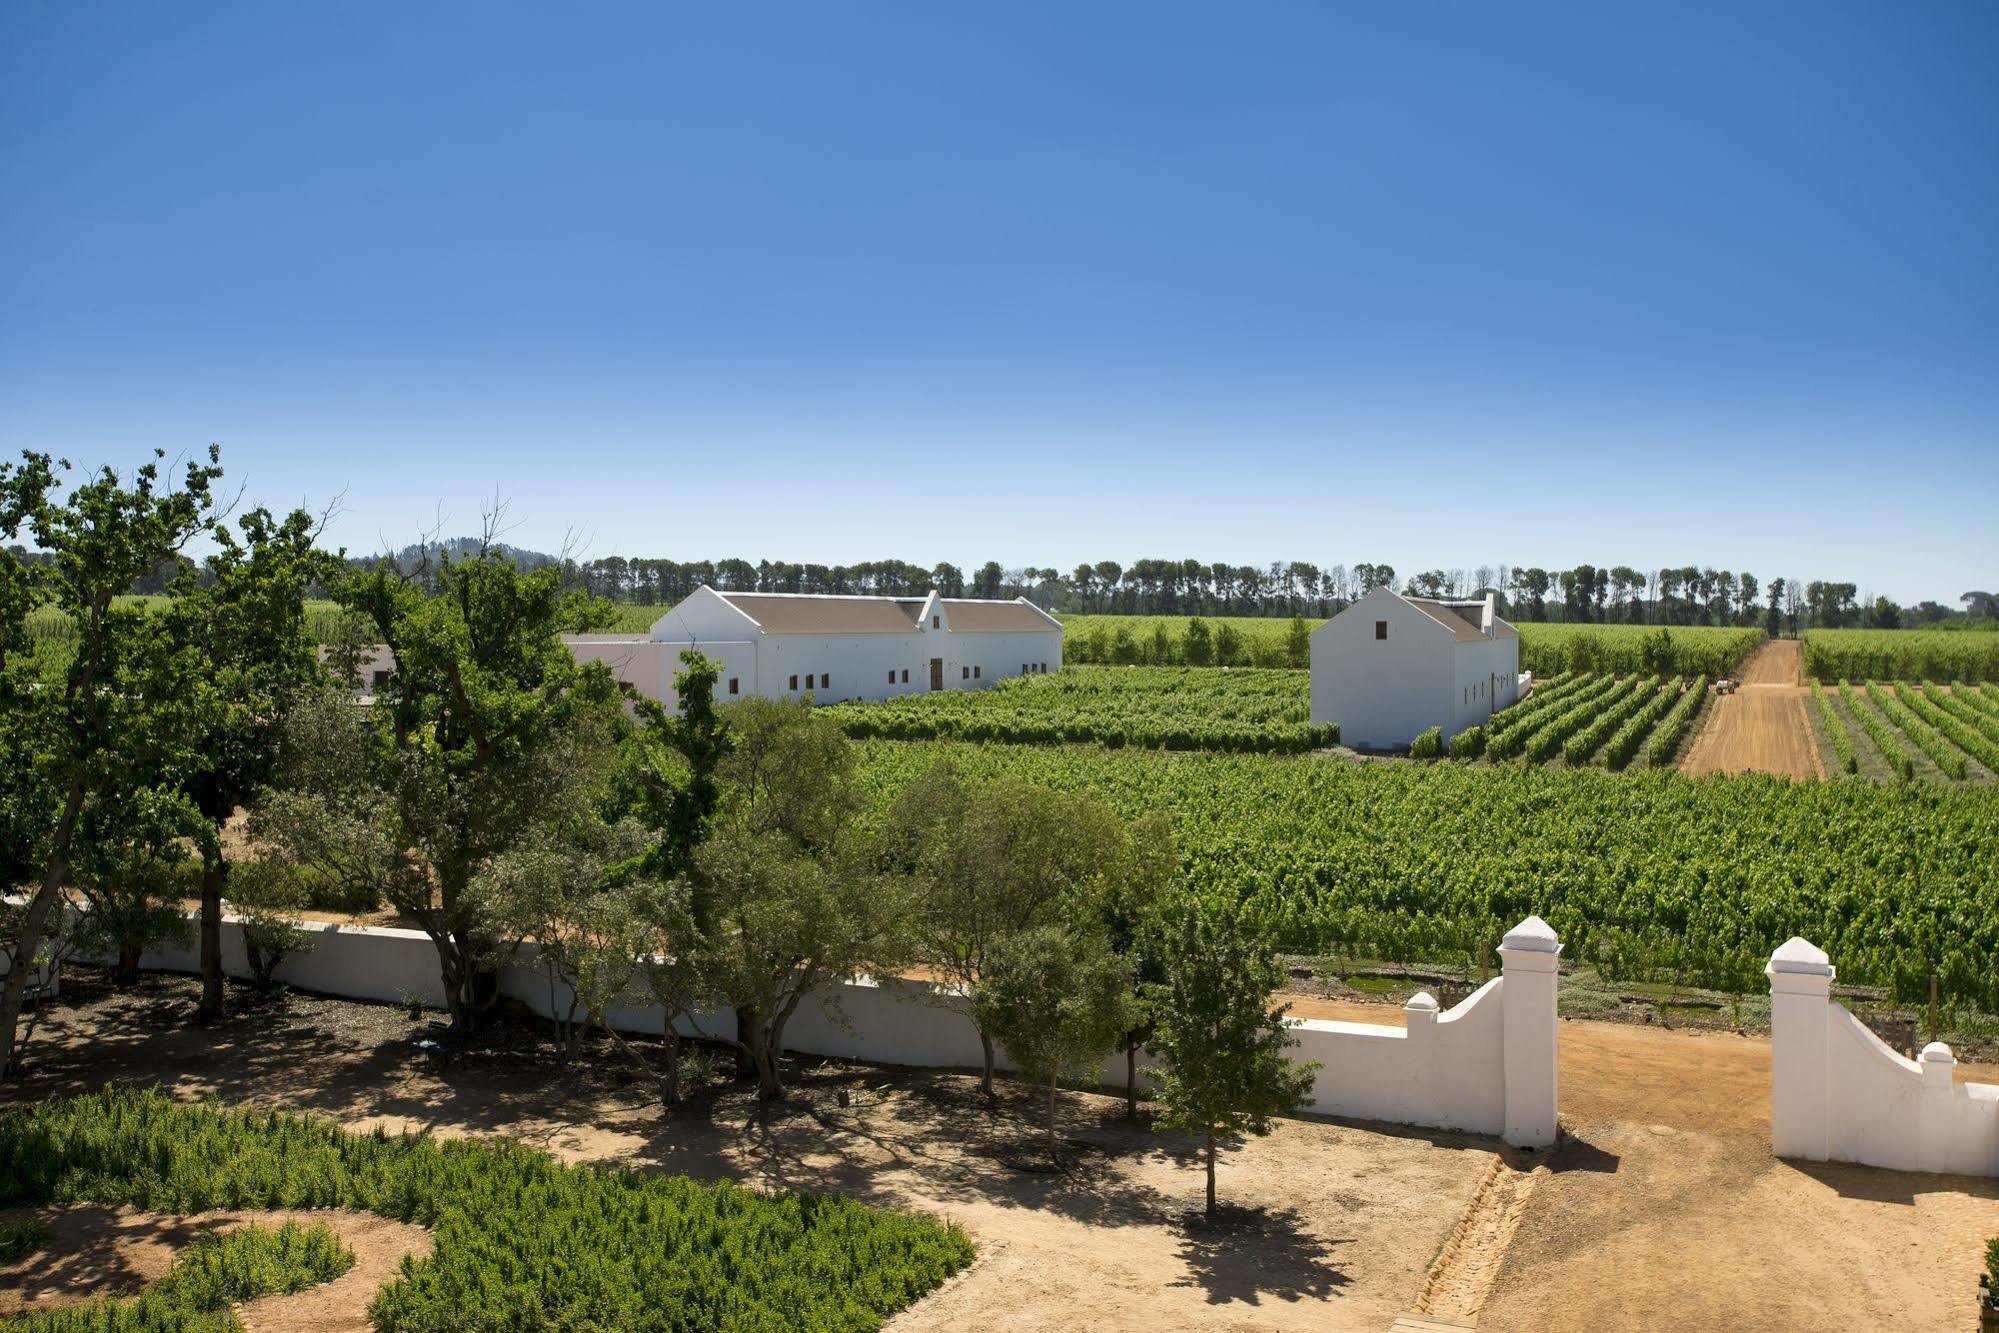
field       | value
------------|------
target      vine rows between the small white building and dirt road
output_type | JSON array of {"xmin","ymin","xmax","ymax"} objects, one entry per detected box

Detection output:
[{"xmin": 1449, "ymin": 671, "xmax": 1707, "ymax": 769}]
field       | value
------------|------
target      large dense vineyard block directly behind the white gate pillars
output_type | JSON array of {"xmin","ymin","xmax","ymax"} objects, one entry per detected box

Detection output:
[{"xmin": 862, "ymin": 739, "xmax": 1999, "ymax": 1011}]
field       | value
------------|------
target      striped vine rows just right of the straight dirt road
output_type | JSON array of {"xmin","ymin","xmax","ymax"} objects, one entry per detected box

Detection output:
[{"xmin": 1811, "ymin": 681, "xmax": 1999, "ymax": 785}]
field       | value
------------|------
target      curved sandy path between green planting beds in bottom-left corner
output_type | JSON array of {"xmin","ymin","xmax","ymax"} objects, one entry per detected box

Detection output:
[{"xmin": 0, "ymin": 1203, "xmax": 432, "ymax": 1333}]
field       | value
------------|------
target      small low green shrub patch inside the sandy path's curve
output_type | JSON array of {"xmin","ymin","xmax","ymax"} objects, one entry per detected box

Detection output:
[{"xmin": 0, "ymin": 1221, "xmax": 354, "ymax": 1333}]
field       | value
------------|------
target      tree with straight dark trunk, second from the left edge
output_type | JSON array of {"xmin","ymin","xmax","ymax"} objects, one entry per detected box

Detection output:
[{"xmin": 160, "ymin": 510, "xmax": 342, "ymax": 1019}]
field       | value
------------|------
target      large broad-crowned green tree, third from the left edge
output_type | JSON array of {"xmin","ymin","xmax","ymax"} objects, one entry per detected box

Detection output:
[{"xmin": 258, "ymin": 544, "xmax": 624, "ymax": 1033}]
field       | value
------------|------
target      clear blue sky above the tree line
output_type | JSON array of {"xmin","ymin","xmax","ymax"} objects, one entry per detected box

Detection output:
[{"xmin": 0, "ymin": 0, "xmax": 1999, "ymax": 602}]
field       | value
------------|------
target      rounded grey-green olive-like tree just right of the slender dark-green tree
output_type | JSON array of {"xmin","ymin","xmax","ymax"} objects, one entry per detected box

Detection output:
[{"xmin": 690, "ymin": 699, "xmax": 908, "ymax": 1099}]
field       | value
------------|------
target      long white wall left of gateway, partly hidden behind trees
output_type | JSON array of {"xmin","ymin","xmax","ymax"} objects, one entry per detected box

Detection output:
[{"xmin": 120, "ymin": 913, "xmax": 1561, "ymax": 1147}]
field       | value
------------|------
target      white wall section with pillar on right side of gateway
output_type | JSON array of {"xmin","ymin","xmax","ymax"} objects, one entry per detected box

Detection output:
[{"xmin": 1763, "ymin": 939, "xmax": 1999, "ymax": 1175}]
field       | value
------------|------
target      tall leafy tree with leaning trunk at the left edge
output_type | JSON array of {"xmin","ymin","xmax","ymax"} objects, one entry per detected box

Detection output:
[{"xmin": 0, "ymin": 450, "xmax": 222, "ymax": 1077}]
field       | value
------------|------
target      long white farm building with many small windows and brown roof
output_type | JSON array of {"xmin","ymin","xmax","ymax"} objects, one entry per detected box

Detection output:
[{"xmin": 566, "ymin": 584, "xmax": 1061, "ymax": 707}]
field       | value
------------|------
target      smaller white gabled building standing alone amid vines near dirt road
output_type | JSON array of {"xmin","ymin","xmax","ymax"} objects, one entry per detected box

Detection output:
[{"xmin": 1311, "ymin": 588, "xmax": 1519, "ymax": 749}]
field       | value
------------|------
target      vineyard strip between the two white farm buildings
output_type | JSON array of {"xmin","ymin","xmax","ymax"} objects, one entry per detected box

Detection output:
[{"xmin": 824, "ymin": 667, "xmax": 1339, "ymax": 753}]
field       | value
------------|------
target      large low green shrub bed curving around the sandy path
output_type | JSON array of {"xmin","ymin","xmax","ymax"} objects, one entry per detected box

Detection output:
[{"xmin": 0, "ymin": 1091, "xmax": 972, "ymax": 1333}]
